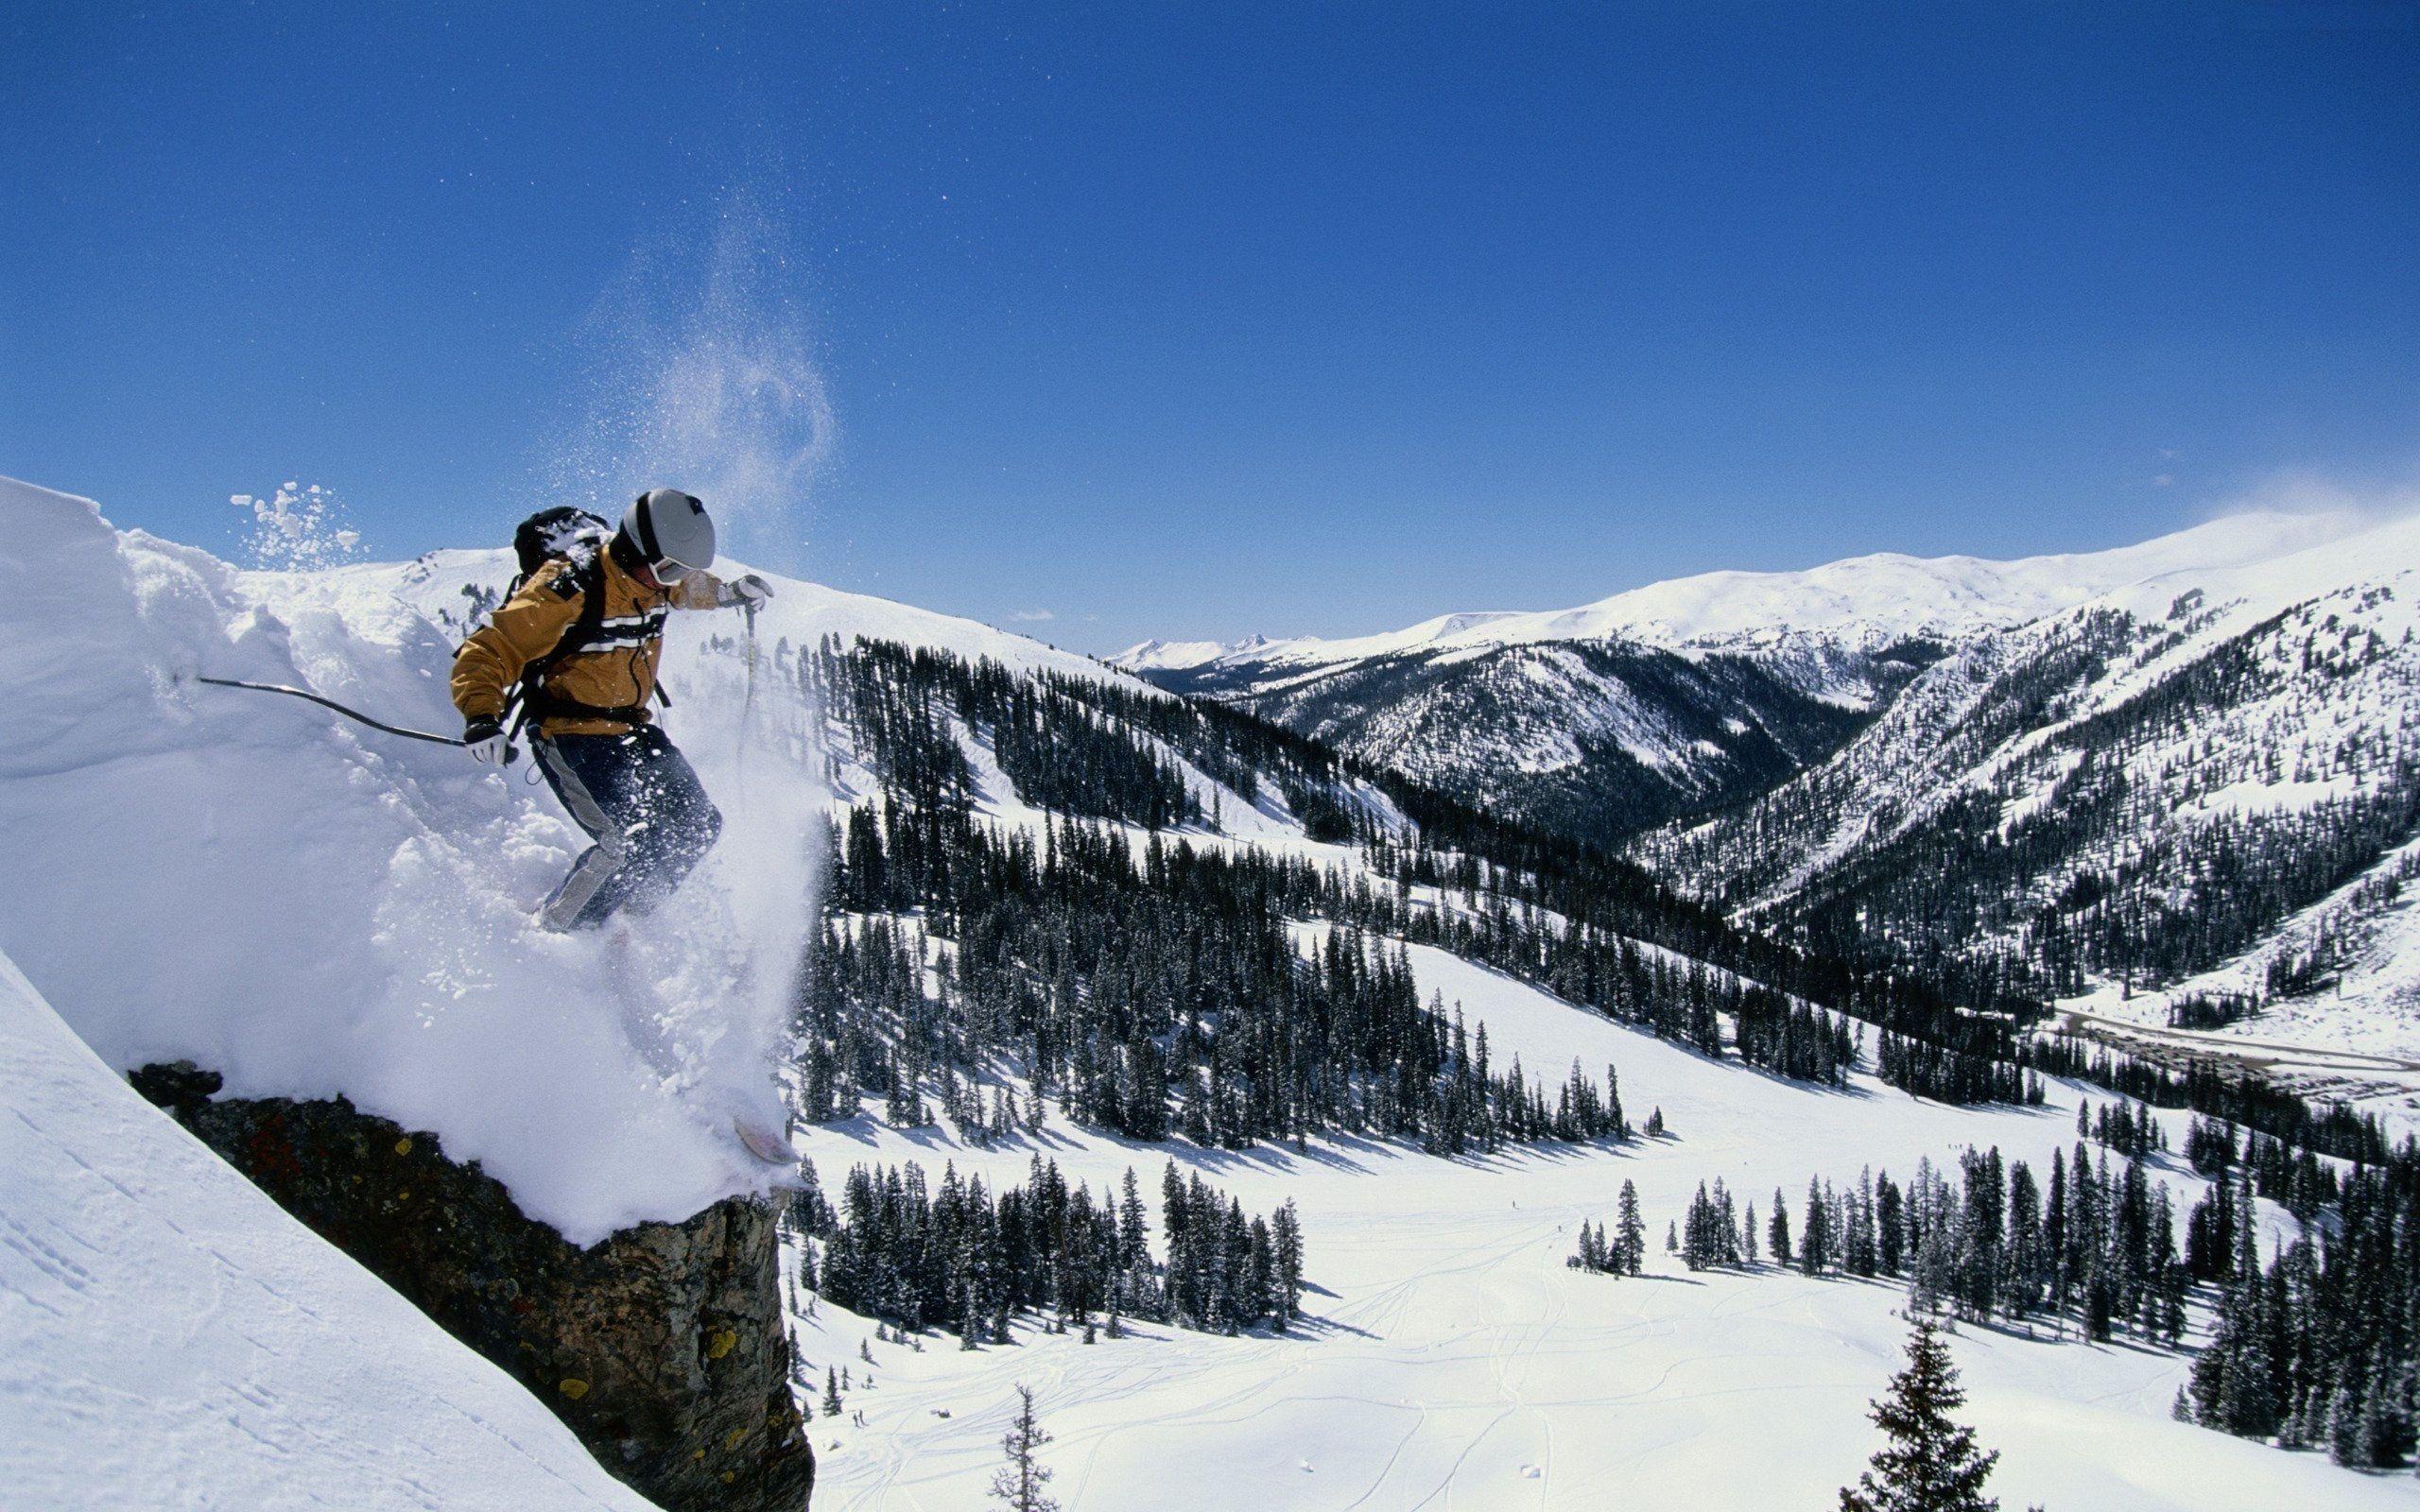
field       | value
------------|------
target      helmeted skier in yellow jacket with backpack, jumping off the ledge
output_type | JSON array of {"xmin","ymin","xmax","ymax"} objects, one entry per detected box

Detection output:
[{"xmin": 453, "ymin": 489, "xmax": 772, "ymax": 929}]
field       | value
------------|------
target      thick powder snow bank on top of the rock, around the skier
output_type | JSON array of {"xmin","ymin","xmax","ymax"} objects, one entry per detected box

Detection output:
[{"xmin": 0, "ymin": 481, "xmax": 821, "ymax": 1244}]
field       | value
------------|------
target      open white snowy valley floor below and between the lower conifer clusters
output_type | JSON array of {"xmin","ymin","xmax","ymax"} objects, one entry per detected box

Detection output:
[{"xmin": 799, "ymin": 951, "xmax": 2420, "ymax": 1512}]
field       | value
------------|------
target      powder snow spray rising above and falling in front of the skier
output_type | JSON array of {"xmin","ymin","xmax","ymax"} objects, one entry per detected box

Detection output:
[{"xmin": 525, "ymin": 194, "xmax": 833, "ymax": 1165}]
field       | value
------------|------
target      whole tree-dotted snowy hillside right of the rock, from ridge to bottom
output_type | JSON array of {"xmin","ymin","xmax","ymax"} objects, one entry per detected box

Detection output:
[{"xmin": 774, "ymin": 624, "xmax": 2408, "ymax": 1507}]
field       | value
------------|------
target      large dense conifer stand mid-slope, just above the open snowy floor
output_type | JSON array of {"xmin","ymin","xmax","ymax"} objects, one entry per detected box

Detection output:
[{"xmin": 799, "ymin": 808, "xmax": 1629, "ymax": 1154}]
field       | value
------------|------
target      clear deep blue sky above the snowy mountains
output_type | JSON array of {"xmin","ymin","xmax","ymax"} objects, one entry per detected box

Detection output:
[{"xmin": 0, "ymin": 0, "xmax": 2420, "ymax": 651}]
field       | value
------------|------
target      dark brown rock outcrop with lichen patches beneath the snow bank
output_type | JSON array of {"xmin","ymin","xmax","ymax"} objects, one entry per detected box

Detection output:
[{"xmin": 133, "ymin": 1062, "xmax": 816, "ymax": 1512}]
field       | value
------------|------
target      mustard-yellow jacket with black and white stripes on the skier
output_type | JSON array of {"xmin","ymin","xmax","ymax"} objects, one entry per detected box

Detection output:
[{"xmin": 453, "ymin": 547, "xmax": 735, "ymax": 738}]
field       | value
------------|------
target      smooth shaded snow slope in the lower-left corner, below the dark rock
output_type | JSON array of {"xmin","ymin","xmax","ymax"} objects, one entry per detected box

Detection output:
[{"xmin": 0, "ymin": 955, "xmax": 647, "ymax": 1512}]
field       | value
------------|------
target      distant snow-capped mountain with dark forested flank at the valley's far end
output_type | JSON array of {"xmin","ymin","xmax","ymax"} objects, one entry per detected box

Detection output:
[{"xmin": 1114, "ymin": 510, "xmax": 2362, "ymax": 839}]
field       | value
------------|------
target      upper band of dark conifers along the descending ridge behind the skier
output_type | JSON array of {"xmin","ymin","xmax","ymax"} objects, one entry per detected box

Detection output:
[{"xmin": 794, "ymin": 641, "xmax": 2031, "ymax": 1112}]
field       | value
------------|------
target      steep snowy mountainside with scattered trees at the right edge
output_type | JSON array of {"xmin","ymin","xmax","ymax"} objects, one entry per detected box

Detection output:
[{"xmin": 1636, "ymin": 520, "xmax": 2420, "ymax": 1089}]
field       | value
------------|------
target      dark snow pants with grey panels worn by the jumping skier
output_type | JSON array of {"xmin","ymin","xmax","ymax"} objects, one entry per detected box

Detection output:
[{"xmin": 530, "ymin": 726, "xmax": 723, "ymax": 929}]
